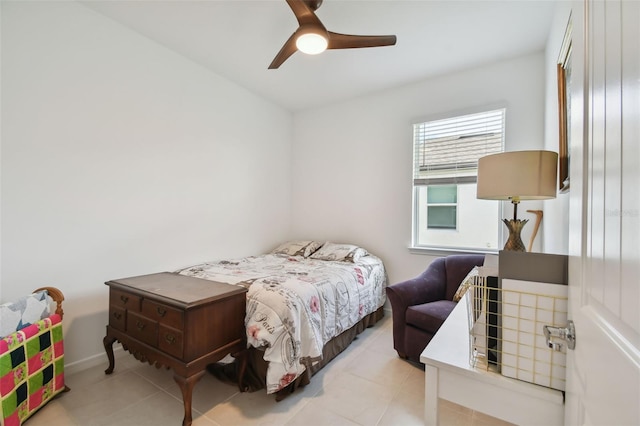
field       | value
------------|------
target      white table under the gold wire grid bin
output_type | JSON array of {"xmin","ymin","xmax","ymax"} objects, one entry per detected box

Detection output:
[{"xmin": 420, "ymin": 292, "xmax": 564, "ymax": 426}]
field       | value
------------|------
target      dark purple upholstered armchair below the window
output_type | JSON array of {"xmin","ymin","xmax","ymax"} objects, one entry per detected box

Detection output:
[{"xmin": 387, "ymin": 254, "xmax": 484, "ymax": 362}]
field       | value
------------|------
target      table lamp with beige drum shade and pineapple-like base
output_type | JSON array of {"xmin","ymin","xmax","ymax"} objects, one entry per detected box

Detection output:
[{"xmin": 477, "ymin": 151, "xmax": 558, "ymax": 251}]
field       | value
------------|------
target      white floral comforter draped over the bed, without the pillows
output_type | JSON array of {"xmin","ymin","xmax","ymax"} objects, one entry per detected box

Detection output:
[{"xmin": 177, "ymin": 254, "xmax": 387, "ymax": 393}]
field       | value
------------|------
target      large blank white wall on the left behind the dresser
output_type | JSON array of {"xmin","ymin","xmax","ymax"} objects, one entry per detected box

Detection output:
[{"xmin": 0, "ymin": 2, "xmax": 292, "ymax": 365}]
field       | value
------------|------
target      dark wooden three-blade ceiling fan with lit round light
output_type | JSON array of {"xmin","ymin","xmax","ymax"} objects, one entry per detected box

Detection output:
[{"xmin": 269, "ymin": 0, "xmax": 396, "ymax": 69}]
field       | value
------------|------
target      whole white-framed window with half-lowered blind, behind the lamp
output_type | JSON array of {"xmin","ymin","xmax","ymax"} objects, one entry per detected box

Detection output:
[{"xmin": 413, "ymin": 109, "xmax": 505, "ymax": 250}]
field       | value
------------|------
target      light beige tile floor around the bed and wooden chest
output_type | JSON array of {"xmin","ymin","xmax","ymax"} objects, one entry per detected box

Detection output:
[{"xmin": 27, "ymin": 313, "xmax": 506, "ymax": 426}]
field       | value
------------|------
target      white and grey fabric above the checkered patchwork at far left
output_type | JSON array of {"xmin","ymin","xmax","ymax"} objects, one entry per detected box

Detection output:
[{"xmin": 0, "ymin": 290, "xmax": 51, "ymax": 337}]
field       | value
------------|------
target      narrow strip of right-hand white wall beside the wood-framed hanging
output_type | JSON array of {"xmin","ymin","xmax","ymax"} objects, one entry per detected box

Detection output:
[{"xmin": 542, "ymin": 1, "xmax": 571, "ymax": 254}]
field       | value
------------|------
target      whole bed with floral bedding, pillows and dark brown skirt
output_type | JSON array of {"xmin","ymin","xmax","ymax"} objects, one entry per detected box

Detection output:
[{"xmin": 176, "ymin": 241, "xmax": 387, "ymax": 400}]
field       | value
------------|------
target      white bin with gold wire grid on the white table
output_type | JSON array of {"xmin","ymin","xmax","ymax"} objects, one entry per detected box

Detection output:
[{"xmin": 467, "ymin": 276, "xmax": 567, "ymax": 391}]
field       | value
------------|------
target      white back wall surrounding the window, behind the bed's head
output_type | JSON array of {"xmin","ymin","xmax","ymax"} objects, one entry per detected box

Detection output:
[{"xmin": 292, "ymin": 52, "xmax": 545, "ymax": 283}]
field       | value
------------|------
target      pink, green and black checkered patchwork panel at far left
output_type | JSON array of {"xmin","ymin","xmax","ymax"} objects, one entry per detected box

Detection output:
[{"xmin": 0, "ymin": 314, "xmax": 65, "ymax": 426}]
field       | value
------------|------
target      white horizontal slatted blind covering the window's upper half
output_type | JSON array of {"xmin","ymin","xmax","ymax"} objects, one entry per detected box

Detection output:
[{"xmin": 413, "ymin": 109, "xmax": 505, "ymax": 185}]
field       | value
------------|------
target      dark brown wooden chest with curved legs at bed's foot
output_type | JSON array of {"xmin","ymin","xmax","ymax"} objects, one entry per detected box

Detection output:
[{"xmin": 103, "ymin": 272, "xmax": 247, "ymax": 425}]
